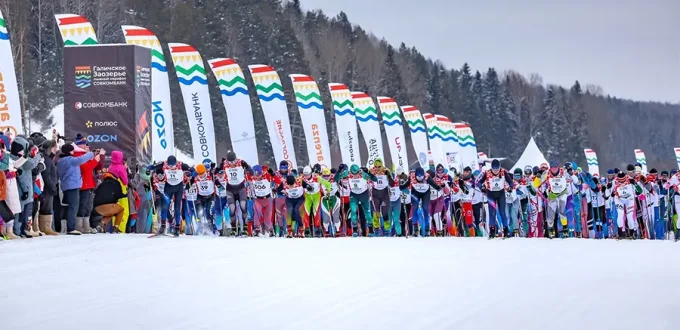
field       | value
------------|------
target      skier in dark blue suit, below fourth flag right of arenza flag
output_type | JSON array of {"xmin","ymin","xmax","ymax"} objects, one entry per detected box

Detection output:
[{"xmin": 411, "ymin": 167, "xmax": 442, "ymax": 236}]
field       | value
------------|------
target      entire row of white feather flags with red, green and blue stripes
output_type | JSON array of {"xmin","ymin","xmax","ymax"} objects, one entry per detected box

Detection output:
[{"xmin": 0, "ymin": 13, "xmax": 680, "ymax": 171}]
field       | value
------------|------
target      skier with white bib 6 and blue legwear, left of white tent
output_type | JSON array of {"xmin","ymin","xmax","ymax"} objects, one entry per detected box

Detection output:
[{"xmin": 478, "ymin": 159, "xmax": 513, "ymax": 238}]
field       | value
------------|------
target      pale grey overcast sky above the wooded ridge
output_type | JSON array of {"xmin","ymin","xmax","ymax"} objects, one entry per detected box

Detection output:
[{"xmin": 301, "ymin": 0, "xmax": 680, "ymax": 103}]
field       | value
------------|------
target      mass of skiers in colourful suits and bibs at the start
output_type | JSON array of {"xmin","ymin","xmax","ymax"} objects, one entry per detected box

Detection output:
[{"xmin": 147, "ymin": 152, "xmax": 680, "ymax": 239}]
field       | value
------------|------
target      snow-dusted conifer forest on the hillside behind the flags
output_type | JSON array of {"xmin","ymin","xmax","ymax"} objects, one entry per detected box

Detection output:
[{"xmin": 0, "ymin": 0, "xmax": 680, "ymax": 169}]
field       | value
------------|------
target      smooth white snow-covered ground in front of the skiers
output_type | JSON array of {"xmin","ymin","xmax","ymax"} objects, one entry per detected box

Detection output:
[{"xmin": 0, "ymin": 235, "xmax": 680, "ymax": 330}]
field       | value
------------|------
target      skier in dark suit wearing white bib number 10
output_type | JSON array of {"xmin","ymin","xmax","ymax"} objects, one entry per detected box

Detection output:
[{"xmin": 222, "ymin": 151, "xmax": 250, "ymax": 232}]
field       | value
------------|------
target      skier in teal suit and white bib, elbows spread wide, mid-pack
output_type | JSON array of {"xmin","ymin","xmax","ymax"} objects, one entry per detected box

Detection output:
[{"xmin": 335, "ymin": 164, "xmax": 377, "ymax": 237}]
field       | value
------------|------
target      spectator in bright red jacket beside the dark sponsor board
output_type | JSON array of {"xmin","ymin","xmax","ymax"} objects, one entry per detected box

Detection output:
[{"xmin": 74, "ymin": 134, "xmax": 106, "ymax": 234}]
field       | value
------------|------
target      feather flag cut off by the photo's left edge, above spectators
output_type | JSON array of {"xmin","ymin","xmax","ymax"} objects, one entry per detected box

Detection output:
[{"xmin": 0, "ymin": 12, "xmax": 24, "ymax": 136}]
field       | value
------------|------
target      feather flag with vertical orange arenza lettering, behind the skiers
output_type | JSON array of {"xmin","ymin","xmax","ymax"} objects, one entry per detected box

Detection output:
[{"xmin": 290, "ymin": 74, "xmax": 333, "ymax": 167}]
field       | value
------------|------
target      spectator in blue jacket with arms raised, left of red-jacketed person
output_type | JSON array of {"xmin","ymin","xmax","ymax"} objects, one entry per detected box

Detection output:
[{"xmin": 57, "ymin": 143, "xmax": 94, "ymax": 235}]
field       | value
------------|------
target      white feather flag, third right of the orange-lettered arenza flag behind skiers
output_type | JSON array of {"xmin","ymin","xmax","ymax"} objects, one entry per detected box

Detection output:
[{"xmin": 378, "ymin": 96, "xmax": 409, "ymax": 173}]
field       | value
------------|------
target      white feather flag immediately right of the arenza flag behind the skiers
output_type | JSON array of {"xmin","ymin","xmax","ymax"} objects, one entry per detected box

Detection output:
[{"xmin": 328, "ymin": 83, "xmax": 361, "ymax": 166}]
